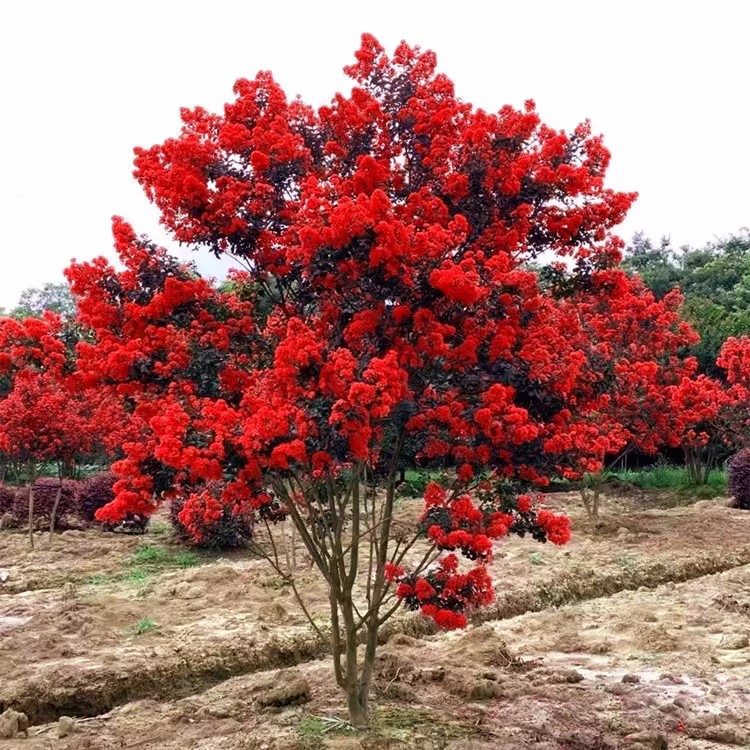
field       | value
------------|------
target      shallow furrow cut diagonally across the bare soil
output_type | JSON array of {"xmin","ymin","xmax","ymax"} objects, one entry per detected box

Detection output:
[{"xmin": 5, "ymin": 545, "xmax": 750, "ymax": 723}]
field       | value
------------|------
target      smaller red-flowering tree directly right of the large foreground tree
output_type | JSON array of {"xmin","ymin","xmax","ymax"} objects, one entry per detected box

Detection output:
[{"xmin": 546, "ymin": 270, "xmax": 718, "ymax": 517}]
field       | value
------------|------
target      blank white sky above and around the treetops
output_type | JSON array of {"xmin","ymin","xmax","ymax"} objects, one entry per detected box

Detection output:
[{"xmin": 0, "ymin": 0, "xmax": 750, "ymax": 307}]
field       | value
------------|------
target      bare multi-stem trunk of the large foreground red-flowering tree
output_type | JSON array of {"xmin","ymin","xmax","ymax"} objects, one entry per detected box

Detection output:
[{"xmin": 276, "ymin": 439, "xmax": 434, "ymax": 727}]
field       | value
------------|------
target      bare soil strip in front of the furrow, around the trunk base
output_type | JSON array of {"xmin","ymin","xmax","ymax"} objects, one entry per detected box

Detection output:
[{"xmin": 7, "ymin": 566, "xmax": 750, "ymax": 750}]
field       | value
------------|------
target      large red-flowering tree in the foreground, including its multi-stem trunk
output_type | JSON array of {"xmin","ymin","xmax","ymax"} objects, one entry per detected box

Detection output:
[{"xmin": 68, "ymin": 36, "xmax": 648, "ymax": 725}]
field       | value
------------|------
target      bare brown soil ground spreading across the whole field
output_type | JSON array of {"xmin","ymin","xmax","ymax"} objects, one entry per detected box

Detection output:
[{"xmin": 0, "ymin": 495, "xmax": 750, "ymax": 750}]
